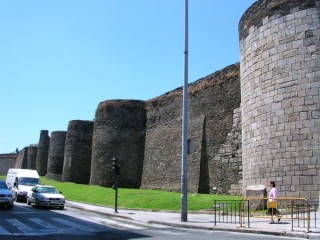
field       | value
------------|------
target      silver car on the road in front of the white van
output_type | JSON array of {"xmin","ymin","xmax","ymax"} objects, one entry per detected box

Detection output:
[{"xmin": 27, "ymin": 185, "xmax": 66, "ymax": 209}]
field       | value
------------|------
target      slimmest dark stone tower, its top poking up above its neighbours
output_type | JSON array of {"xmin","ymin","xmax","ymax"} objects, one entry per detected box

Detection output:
[{"xmin": 36, "ymin": 130, "xmax": 50, "ymax": 176}]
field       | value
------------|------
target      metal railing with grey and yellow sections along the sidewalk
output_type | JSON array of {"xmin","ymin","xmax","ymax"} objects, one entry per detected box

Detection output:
[{"xmin": 213, "ymin": 197, "xmax": 320, "ymax": 232}]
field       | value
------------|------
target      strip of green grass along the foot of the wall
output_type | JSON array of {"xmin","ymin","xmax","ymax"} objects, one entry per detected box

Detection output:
[{"xmin": 0, "ymin": 176, "xmax": 240, "ymax": 211}]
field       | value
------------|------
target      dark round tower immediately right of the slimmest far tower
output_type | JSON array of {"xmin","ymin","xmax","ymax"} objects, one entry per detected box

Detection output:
[{"xmin": 46, "ymin": 131, "xmax": 66, "ymax": 181}]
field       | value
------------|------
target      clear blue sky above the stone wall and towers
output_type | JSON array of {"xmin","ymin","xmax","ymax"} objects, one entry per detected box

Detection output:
[{"xmin": 0, "ymin": 0, "xmax": 255, "ymax": 153}]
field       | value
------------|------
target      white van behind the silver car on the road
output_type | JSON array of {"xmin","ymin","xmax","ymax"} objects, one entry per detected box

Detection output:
[{"xmin": 6, "ymin": 168, "xmax": 40, "ymax": 202}]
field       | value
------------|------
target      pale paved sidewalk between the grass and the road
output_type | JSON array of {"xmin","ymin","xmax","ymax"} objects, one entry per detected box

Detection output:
[{"xmin": 66, "ymin": 201, "xmax": 320, "ymax": 239}]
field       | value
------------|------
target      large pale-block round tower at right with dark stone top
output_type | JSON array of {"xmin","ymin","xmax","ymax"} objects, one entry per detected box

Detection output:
[{"xmin": 239, "ymin": 0, "xmax": 320, "ymax": 200}]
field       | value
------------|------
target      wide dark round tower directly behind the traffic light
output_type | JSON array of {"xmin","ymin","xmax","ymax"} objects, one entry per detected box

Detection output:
[{"xmin": 90, "ymin": 100, "xmax": 146, "ymax": 188}]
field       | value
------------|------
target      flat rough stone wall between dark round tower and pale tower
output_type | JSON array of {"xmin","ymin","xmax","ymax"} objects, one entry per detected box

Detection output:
[{"xmin": 142, "ymin": 64, "xmax": 241, "ymax": 193}]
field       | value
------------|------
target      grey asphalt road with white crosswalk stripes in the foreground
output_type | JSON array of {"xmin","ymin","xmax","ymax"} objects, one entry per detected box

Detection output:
[{"xmin": 0, "ymin": 203, "xmax": 304, "ymax": 240}]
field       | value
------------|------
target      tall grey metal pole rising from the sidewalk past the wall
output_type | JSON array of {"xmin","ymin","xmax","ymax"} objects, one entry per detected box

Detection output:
[{"xmin": 181, "ymin": 0, "xmax": 188, "ymax": 222}]
